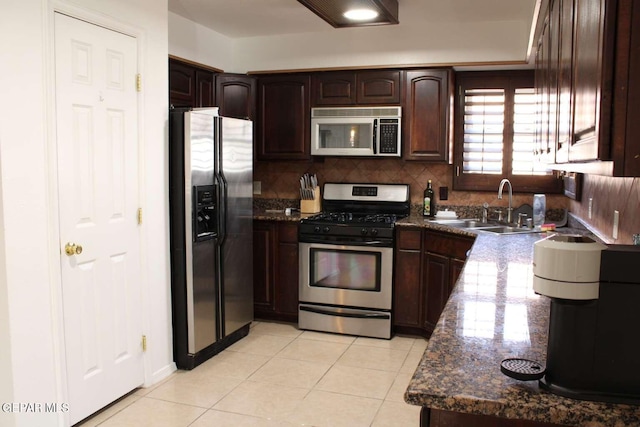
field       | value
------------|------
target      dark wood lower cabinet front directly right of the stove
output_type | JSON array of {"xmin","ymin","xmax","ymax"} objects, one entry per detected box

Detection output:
[{"xmin": 393, "ymin": 228, "xmax": 423, "ymax": 328}]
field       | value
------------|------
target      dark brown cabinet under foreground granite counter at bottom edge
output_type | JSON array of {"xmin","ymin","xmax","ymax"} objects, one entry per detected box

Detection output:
[{"xmin": 420, "ymin": 408, "xmax": 558, "ymax": 427}]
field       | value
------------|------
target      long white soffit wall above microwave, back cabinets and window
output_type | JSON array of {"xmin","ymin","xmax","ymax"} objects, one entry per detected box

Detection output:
[{"xmin": 232, "ymin": 22, "xmax": 528, "ymax": 72}]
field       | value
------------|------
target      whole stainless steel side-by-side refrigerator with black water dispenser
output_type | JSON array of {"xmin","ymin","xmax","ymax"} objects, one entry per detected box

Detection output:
[{"xmin": 169, "ymin": 108, "xmax": 253, "ymax": 369}]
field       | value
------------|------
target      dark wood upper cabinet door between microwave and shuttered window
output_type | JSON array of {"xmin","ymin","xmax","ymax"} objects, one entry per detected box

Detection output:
[{"xmin": 402, "ymin": 70, "xmax": 452, "ymax": 161}]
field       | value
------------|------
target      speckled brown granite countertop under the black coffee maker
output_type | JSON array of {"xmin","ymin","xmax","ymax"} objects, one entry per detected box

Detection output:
[{"xmin": 404, "ymin": 231, "xmax": 640, "ymax": 427}]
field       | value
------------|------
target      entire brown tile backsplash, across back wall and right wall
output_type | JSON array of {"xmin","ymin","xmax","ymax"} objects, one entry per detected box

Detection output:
[{"xmin": 253, "ymin": 157, "xmax": 640, "ymax": 244}]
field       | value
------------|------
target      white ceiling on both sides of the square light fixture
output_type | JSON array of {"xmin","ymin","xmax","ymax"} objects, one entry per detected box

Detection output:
[{"xmin": 168, "ymin": 0, "xmax": 539, "ymax": 38}]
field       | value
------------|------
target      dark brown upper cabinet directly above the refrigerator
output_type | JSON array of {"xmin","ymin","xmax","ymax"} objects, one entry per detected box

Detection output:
[{"xmin": 169, "ymin": 58, "xmax": 221, "ymax": 107}]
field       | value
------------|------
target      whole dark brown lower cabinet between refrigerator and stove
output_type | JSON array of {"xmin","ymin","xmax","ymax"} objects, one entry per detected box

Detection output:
[{"xmin": 253, "ymin": 221, "xmax": 298, "ymax": 323}]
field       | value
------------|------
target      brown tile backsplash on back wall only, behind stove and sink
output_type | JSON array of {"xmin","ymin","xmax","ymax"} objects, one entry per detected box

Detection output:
[{"xmin": 253, "ymin": 157, "xmax": 569, "ymax": 209}]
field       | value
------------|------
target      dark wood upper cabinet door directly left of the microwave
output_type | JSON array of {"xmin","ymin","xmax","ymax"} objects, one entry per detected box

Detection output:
[{"xmin": 257, "ymin": 75, "xmax": 311, "ymax": 160}]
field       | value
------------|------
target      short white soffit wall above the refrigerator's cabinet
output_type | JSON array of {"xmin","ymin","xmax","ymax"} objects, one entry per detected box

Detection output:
[{"xmin": 169, "ymin": 12, "xmax": 234, "ymax": 71}]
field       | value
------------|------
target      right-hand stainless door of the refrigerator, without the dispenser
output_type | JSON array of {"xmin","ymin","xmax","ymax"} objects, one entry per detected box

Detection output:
[{"xmin": 219, "ymin": 117, "xmax": 253, "ymax": 336}]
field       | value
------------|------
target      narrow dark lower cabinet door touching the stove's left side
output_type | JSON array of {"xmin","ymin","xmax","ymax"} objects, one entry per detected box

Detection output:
[{"xmin": 275, "ymin": 223, "xmax": 299, "ymax": 321}]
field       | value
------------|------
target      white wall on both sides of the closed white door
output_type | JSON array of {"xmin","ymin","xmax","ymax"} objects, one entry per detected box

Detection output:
[{"xmin": 0, "ymin": 0, "xmax": 174, "ymax": 426}]
